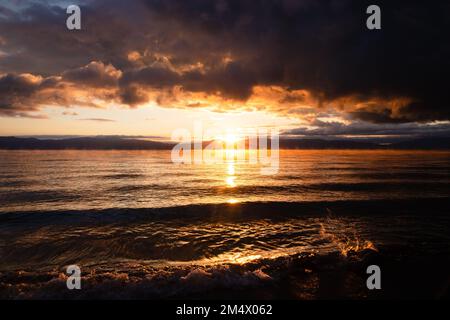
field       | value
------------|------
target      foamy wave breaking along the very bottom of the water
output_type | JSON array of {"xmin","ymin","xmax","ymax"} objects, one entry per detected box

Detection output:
[{"xmin": 0, "ymin": 249, "xmax": 450, "ymax": 300}]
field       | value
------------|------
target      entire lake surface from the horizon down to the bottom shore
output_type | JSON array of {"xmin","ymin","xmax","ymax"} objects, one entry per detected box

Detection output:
[{"xmin": 0, "ymin": 150, "xmax": 450, "ymax": 299}]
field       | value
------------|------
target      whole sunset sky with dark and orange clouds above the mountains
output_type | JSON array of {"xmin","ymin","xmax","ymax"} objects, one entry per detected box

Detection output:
[{"xmin": 0, "ymin": 0, "xmax": 450, "ymax": 139}]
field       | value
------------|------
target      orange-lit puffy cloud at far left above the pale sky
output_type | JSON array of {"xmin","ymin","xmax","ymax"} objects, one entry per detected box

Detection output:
[{"xmin": 0, "ymin": 61, "xmax": 121, "ymax": 117}]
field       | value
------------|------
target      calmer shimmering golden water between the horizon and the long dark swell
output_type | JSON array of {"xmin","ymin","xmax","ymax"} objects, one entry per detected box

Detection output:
[{"xmin": 0, "ymin": 150, "xmax": 450, "ymax": 211}]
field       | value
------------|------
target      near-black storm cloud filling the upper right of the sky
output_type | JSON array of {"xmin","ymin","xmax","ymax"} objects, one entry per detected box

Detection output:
[{"xmin": 142, "ymin": 0, "xmax": 450, "ymax": 122}]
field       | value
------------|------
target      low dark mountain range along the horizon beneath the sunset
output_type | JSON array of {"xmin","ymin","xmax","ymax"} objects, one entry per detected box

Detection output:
[{"xmin": 0, "ymin": 137, "xmax": 450, "ymax": 150}]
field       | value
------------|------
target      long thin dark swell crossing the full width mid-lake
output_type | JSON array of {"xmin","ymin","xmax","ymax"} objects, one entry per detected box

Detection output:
[{"xmin": 0, "ymin": 198, "xmax": 450, "ymax": 224}]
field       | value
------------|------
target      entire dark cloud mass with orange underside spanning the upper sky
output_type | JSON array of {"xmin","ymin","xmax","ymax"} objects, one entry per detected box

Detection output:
[{"xmin": 0, "ymin": 0, "xmax": 450, "ymax": 124}]
